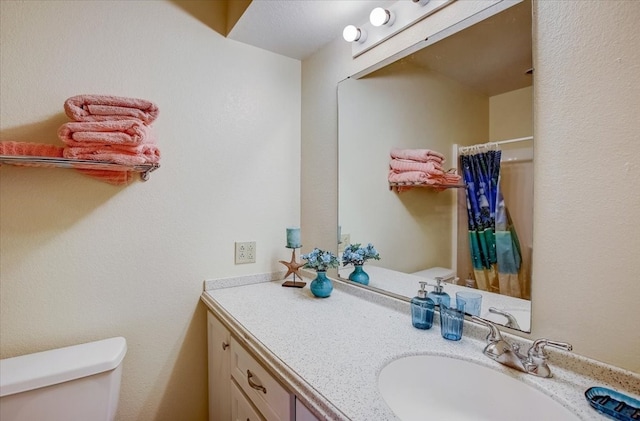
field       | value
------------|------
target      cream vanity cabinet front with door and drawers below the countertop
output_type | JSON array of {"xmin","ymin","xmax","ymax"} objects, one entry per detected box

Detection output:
[{"xmin": 207, "ymin": 312, "xmax": 317, "ymax": 421}]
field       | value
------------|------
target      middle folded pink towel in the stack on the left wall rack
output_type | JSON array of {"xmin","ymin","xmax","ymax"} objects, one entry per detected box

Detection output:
[{"xmin": 58, "ymin": 120, "xmax": 155, "ymax": 146}]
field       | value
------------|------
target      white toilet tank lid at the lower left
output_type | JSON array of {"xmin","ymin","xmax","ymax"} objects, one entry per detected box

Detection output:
[{"xmin": 0, "ymin": 337, "xmax": 127, "ymax": 397}]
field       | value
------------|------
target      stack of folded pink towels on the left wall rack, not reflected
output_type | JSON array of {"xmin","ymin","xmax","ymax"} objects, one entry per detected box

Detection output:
[{"xmin": 58, "ymin": 95, "xmax": 160, "ymax": 184}]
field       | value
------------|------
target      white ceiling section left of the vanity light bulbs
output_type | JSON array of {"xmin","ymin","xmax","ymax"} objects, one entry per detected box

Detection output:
[{"xmin": 228, "ymin": 0, "xmax": 394, "ymax": 60}]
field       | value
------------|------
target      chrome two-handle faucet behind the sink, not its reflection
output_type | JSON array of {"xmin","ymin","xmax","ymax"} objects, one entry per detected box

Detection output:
[{"xmin": 471, "ymin": 316, "xmax": 573, "ymax": 377}]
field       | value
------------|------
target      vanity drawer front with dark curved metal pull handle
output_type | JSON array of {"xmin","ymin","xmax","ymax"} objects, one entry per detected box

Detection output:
[{"xmin": 231, "ymin": 337, "xmax": 294, "ymax": 421}]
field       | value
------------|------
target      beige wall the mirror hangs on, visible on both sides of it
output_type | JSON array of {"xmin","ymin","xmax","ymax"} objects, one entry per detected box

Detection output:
[{"xmin": 301, "ymin": 0, "xmax": 640, "ymax": 372}]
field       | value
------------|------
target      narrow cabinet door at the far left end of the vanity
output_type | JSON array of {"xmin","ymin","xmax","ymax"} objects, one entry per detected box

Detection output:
[{"xmin": 207, "ymin": 312, "xmax": 231, "ymax": 421}]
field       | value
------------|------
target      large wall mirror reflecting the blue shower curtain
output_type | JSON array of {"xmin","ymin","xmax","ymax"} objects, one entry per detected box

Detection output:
[{"xmin": 338, "ymin": 0, "xmax": 534, "ymax": 331}]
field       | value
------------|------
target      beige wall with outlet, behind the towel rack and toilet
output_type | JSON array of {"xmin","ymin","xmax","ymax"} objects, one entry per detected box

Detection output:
[{"xmin": 0, "ymin": 1, "xmax": 301, "ymax": 421}]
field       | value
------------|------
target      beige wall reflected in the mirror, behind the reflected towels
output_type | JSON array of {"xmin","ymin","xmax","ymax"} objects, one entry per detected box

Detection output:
[{"xmin": 338, "ymin": 59, "xmax": 489, "ymax": 273}]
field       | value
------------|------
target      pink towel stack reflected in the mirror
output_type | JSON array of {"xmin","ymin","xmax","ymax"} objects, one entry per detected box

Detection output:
[{"xmin": 389, "ymin": 148, "xmax": 461, "ymax": 192}]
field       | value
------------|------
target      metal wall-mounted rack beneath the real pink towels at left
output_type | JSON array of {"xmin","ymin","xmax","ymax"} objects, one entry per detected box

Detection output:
[{"xmin": 0, "ymin": 155, "xmax": 160, "ymax": 181}]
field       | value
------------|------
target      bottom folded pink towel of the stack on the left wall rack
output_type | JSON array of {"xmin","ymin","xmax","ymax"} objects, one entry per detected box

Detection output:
[{"xmin": 63, "ymin": 143, "xmax": 160, "ymax": 165}]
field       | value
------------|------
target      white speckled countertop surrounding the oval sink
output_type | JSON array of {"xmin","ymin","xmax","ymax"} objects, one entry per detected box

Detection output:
[{"xmin": 202, "ymin": 277, "xmax": 640, "ymax": 421}]
